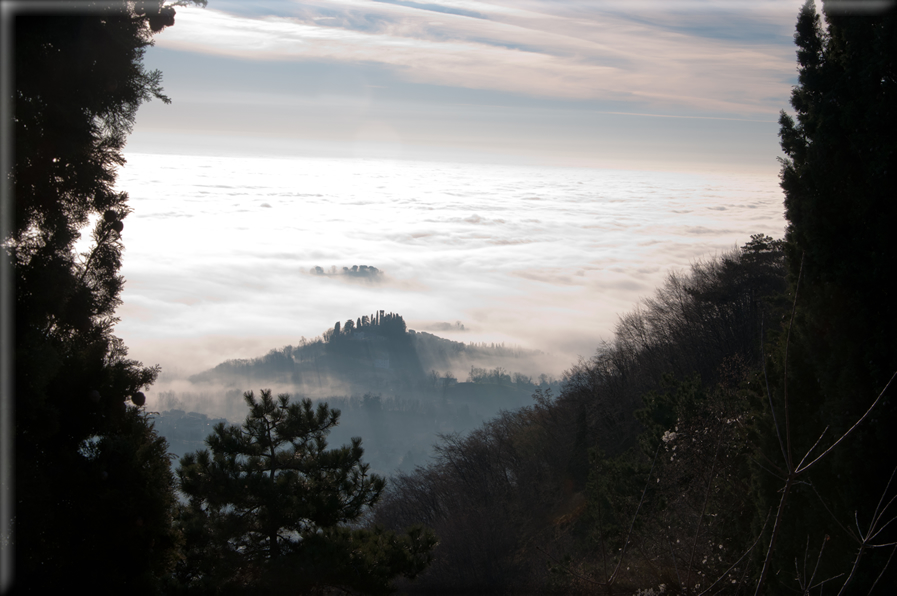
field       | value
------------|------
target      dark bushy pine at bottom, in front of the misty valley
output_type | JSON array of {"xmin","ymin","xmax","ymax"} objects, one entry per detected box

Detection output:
[{"xmin": 176, "ymin": 390, "xmax": 434, "ymax": 594}]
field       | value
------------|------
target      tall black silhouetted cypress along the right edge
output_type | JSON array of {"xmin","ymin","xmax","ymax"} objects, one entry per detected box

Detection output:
[{"xmin": 757, "ymin": 2, "xmax": 897, "ymax": 593}]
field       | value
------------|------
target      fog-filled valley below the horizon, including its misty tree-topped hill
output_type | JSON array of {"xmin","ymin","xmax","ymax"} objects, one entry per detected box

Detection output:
[{"xmin": 110, "ymin": 153, "xmax": 784, "ymax": 474}]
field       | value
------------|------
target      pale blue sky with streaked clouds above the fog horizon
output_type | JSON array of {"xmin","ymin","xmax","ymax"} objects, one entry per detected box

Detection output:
[{"xmin": 129, "ymin": 0, "xmax": 801, "ymax": 173}]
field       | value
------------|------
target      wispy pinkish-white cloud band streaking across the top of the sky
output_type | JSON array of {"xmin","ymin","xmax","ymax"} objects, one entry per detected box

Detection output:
[{"xmin": 157, "ymin": 0, "xmax": 798, "ymax": 117}]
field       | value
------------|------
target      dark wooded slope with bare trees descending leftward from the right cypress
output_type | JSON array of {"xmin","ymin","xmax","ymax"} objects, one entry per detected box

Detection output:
[{"xmin": 375, "ymin": 236, "xmax": 785, "ymax": 593}]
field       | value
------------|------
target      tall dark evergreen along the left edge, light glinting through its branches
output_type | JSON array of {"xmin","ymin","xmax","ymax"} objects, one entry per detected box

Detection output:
[{"xmin": 3, "ymin": 1, "xmax": 203, "ymax": 593}]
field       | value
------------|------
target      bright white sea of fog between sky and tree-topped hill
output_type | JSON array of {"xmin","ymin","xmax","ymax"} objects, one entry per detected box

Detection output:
[{"xmin": 108, "ymin": 153, "xmax": 785, "ymax": 403}]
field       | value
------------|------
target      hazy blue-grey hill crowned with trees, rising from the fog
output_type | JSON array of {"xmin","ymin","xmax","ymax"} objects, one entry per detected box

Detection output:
[{"xmin": 163, "ymin": 311, "xmax": 560, "ymax": 474}]
